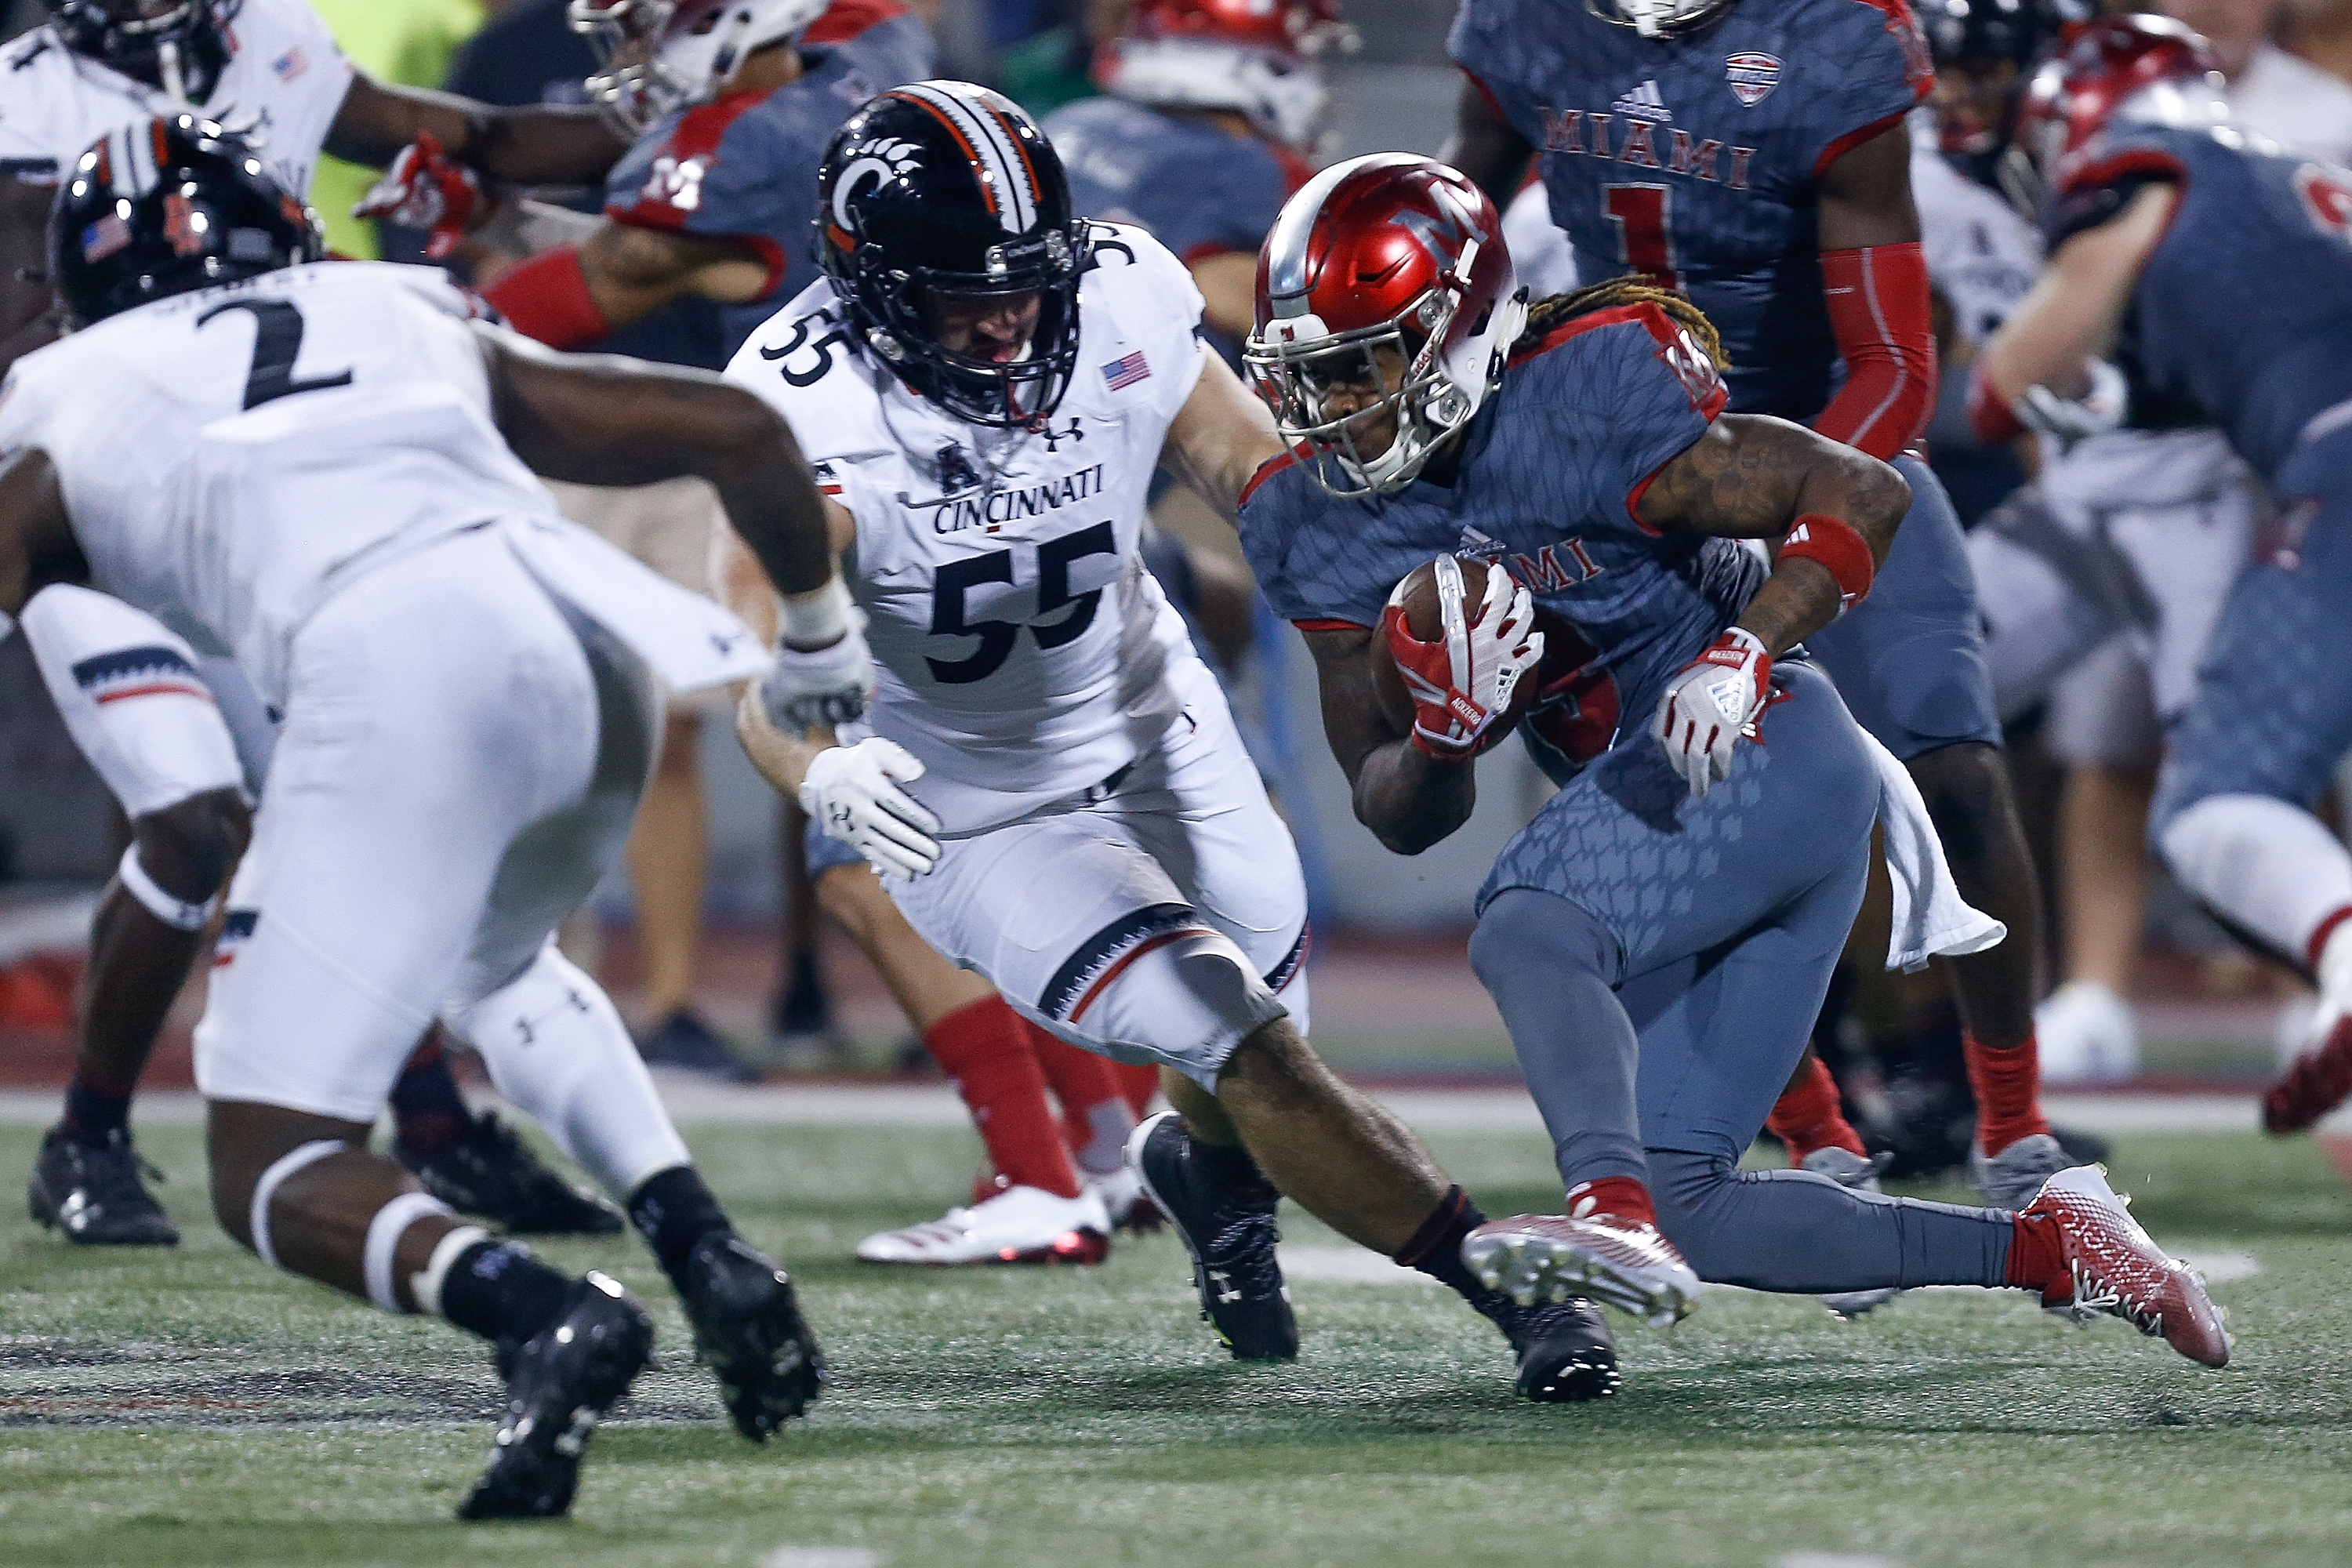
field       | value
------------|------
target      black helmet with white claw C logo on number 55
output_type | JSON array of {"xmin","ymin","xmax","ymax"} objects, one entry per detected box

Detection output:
[{"xmin": 816, "ymin": 82, "xmax": 1094, "ymax": 428}]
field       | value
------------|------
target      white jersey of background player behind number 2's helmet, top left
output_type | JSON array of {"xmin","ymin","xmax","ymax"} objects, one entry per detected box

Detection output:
[{"xmin": 0, "ymin": 0, "xmax": 353, "ymax": 195}]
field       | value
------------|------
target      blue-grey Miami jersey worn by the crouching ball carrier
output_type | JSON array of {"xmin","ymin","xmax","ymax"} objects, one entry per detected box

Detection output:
[{"xmin": 1242, "ymin": 306, "xmax": 1764, "ymax": 724}]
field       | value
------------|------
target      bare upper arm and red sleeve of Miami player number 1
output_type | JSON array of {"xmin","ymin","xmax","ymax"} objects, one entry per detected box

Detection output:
[{"xmin": 1813, "ymin": 120, "xmax": 1936, "ymax": 459}]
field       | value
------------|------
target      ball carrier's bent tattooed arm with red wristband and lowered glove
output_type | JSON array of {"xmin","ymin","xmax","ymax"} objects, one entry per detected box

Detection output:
[{"xmin": 1635, "ymin": 414, "xmax": 1910, "ymax": 659}]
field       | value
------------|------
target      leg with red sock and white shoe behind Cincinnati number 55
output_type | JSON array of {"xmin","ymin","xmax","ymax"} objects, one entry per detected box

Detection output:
[{"xmin": 807, "ymin": 832, "xmax": 1110, "ymax": 1265}]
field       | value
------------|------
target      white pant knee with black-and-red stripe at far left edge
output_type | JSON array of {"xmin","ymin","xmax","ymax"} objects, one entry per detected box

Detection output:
[{"xmin": 24, "ymin": 586, "xmax": 245, "ymax": 820}]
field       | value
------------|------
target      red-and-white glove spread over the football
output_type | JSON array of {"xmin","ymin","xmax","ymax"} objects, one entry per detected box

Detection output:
[{"xmin": 1381, "ymin": 555, "xmax": 1543, "ymax": 762}]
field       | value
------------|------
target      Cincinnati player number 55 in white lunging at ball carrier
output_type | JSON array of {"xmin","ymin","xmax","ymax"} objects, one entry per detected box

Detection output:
[{"xmin": 727, "ymin": 82, "xmax": 1616, "ymax": 1396}]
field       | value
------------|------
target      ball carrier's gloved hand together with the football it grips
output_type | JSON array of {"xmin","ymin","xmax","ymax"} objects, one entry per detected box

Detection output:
[{"xmin": 1371, "ymin": 555, "xmax": 1543, "ymax": 762}]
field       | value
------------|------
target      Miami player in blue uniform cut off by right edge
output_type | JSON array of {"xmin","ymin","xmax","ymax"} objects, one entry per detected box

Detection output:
[{"xmin": 1973, "ymin": 16, "xmax": 2352, "ymax": 1133}]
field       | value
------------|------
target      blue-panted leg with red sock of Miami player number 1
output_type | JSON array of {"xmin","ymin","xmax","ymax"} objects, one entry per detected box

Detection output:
[{"xmin": 1806, "ymin": 459, "xmax": 2065, "ymax": 1199}]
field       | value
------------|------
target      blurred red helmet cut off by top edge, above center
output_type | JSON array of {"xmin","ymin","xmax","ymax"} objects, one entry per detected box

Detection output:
[{"xmin": 1094, "ymin": 0, "xmax": 1357, "ymax": 151}]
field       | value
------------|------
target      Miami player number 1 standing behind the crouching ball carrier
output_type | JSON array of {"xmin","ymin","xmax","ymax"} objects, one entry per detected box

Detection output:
[{"xmin": 1446, "ymin": 0, "xmax": 2067, "ymax": 1206}]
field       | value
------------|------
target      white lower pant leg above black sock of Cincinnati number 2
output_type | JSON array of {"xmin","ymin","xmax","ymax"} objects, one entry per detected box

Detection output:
[{"xmin": 442, "ymin": 942, "xmax": 691, "ymax": 1201}]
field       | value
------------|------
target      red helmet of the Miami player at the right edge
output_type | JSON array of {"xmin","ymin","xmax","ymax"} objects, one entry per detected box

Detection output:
[{"xmin": 2016, "ymin": 16, "xmax": 2230, "ymax": 201}]
